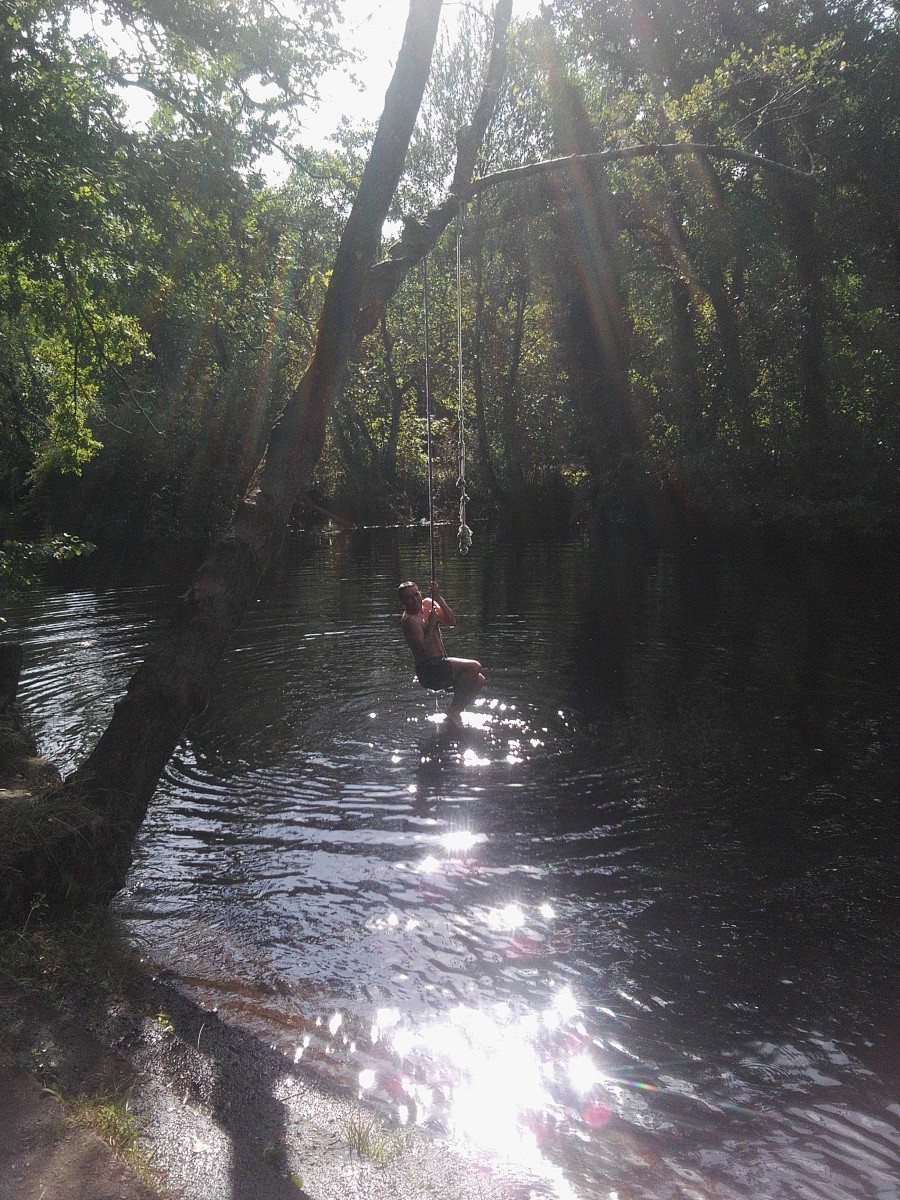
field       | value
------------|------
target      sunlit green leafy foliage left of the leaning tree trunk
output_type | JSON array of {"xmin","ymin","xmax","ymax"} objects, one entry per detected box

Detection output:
[{"xmin": 0, "ymin": 0, "xmax": 341, "ymax": 538}]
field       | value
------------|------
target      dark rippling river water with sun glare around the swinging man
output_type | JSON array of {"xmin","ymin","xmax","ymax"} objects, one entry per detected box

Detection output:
[{"xmin": 5, "ymin": 529, "xmax": 900, "ymax": 1200}]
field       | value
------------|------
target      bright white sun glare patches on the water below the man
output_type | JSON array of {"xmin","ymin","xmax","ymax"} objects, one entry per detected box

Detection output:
[{"xmin": 289, "ymin": 758, "xmax": 616, "ymax": 1200}]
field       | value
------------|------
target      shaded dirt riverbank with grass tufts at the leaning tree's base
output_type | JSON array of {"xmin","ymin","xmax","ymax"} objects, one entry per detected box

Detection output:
[{"xmin": 0, "ymin": 704, "xmax": 530, "ymax": 1200}]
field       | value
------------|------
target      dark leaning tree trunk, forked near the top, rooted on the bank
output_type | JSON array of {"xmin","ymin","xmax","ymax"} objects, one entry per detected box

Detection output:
[{"xmin": 0, "ymin": 0, "xmax": 511, "ymax": 916}]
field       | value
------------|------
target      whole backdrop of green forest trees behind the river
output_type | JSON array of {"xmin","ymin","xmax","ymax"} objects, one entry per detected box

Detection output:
[{"xmin": 0, "ymin": 0, "xmax": 900, "ymax": 592}]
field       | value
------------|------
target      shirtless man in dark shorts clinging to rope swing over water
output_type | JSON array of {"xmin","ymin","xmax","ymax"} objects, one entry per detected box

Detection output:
[{"xmin": 398, "ymin": 580, "xmax": 485, "ymax": 730}]
